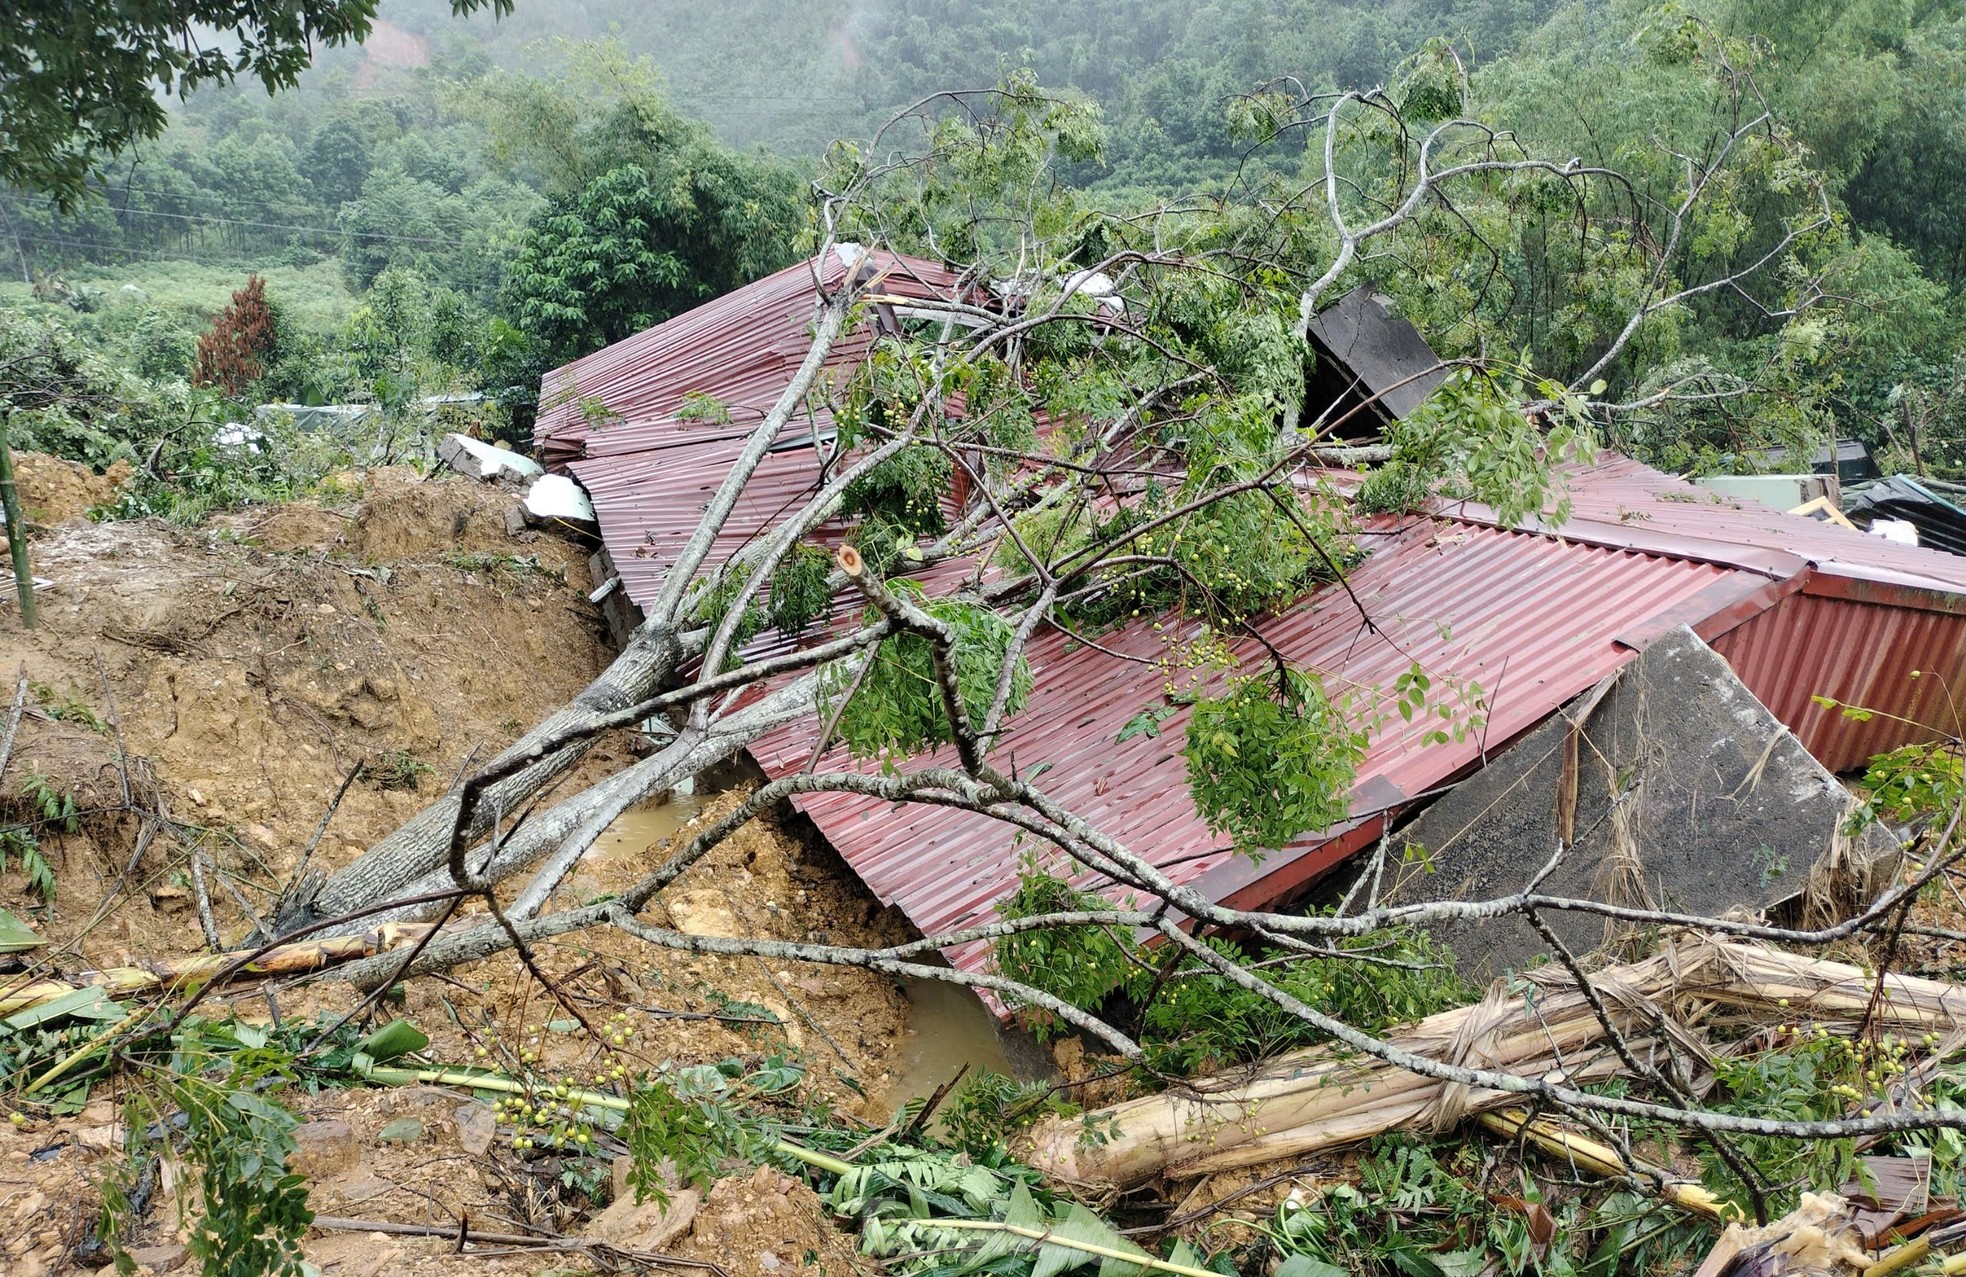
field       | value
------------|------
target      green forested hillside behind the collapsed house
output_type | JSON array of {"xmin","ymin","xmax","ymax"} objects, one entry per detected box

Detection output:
[{"xmin": 0, "ymin": 0, "xmax": 1966, "ymax": 487}]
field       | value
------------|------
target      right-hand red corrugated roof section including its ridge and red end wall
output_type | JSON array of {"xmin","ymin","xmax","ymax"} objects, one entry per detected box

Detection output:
[{"xmin": 753, "ymin": 458, "xmax": 1966, "ymax": 967}]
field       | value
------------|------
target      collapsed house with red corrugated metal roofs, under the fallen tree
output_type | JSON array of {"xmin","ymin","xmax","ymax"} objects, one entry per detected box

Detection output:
[{"xmin": 535, "ymin": 253, "xmax": 1966, "ymax": 986}]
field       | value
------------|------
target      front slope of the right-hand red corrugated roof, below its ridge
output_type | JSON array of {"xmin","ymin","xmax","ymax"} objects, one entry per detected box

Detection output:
[{"xmin": 753, "ymin": 521, "xmax": 1732, "ymax": 967}]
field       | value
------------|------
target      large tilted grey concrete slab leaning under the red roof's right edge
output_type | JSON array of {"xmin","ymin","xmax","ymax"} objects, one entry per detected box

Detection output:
[{"xmin": 1380, "ymin": 627, "xmax": 1897, "ymax": 982}]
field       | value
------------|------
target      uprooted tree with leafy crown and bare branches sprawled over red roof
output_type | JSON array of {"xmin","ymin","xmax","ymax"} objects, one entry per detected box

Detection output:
[{"xmin": 61, "ymin": 61, "xmax": 1966, "ymax": 1225}]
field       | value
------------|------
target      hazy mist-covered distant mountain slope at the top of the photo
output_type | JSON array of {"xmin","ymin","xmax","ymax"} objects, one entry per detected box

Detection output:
[{"xmin": 364, "ymin": 0, "xmax": 1553, "ymax": 163}]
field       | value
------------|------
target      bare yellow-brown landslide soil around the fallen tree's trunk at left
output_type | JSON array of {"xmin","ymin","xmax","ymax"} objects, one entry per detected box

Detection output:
[{"xmin": 0, "ymin": 456, "xmax": 904, "ymax": 1277}]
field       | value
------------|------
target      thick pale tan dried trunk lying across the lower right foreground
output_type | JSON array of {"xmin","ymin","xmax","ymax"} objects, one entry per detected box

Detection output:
[{"xmin": 1022, "ymin": 935, "xmax": 1966, "ymax": 1185}]
